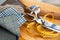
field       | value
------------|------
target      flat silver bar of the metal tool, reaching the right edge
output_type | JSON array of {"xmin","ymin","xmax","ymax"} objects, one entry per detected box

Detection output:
[{"xmin": 44, "ymin": 21, "xmax": 60, "ymax": 33}]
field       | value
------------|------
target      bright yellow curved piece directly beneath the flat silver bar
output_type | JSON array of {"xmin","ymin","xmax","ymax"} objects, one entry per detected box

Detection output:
[{"xmin": 37, "ymin": 25, "xmax": 58, "ymax": 37}]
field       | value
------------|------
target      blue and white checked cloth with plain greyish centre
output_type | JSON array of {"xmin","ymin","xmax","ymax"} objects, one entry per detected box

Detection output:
[{"xmin": 0, "ymin": 7, "xmax": 26, "ymax": 35}]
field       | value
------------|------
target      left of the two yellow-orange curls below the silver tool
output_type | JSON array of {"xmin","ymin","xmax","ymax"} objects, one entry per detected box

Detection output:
[{"xmin": 27, "ymin": 22, "xmax": 39, "ymax": 36}]
